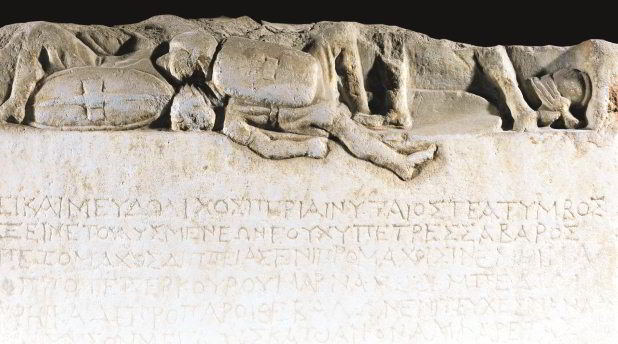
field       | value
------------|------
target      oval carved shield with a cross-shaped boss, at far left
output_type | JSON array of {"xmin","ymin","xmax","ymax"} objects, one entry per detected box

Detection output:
[{"xmin": 29, "ymin": 67, "xmax": 174, "ymax": 130}]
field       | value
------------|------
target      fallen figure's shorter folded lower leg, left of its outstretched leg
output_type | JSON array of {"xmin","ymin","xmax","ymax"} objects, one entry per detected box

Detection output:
[{"xmin": 222, "ymin": 109, "xmax": 328, "ymax": 159}]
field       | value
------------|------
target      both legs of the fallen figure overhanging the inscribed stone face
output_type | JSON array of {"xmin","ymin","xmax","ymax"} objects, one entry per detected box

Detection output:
[{"xmin": 223, "ymin": 102, "xmax": 436, "ymax": 180}]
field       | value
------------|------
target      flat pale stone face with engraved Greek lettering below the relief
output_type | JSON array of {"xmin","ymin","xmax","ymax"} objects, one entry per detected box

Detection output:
[{"xmin": 0, "ymin": 125, "xmax": 618, "ymax": 344}]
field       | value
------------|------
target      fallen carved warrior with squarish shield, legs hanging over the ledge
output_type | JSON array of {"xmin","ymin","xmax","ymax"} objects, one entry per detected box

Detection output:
[{"xmin": 157, "ymin": 32, "xmax": 436, "ymax": 180}]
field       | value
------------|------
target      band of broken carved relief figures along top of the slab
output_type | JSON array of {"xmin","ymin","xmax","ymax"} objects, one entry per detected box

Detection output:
[{"xmin": 0, "ymin": 17, "xmax": 618, "ymax": 180}]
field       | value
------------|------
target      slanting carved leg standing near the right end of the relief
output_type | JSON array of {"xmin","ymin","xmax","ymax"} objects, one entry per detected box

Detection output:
[{"xmin": 476, "ymin": 46, "xmax": 538, "ymax": 131}]
